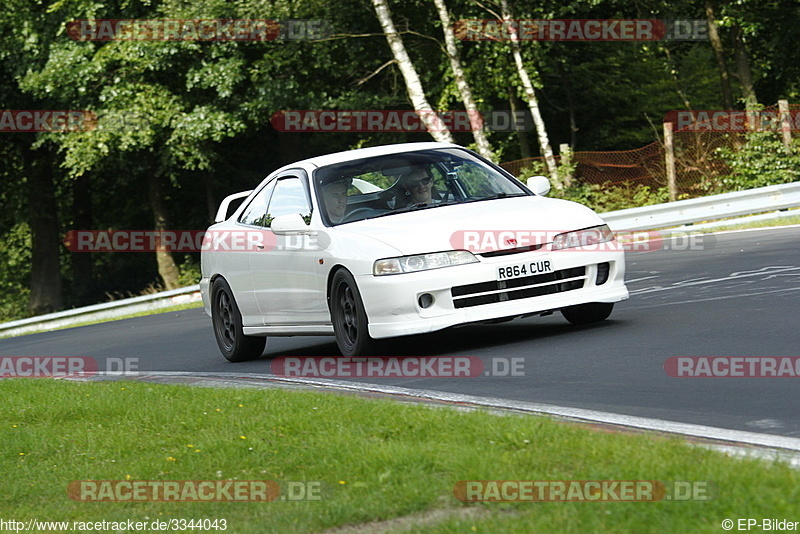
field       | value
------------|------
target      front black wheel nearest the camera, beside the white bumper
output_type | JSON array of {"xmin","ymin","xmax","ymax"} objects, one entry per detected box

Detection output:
[{"xmin": 330, "ymin": 269, "xmax": 374, "ymax": 356}]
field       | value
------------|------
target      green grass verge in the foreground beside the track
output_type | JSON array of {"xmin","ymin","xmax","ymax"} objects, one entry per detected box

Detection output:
[{"xmin": 0, "ymin": 379, "xmax": 800, "ymax": 534}]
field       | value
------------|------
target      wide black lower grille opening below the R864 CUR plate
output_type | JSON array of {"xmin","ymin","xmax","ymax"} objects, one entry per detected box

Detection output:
[{"xmin": 450, "ymin": 267, "xmax": 586, "ymax": 308}]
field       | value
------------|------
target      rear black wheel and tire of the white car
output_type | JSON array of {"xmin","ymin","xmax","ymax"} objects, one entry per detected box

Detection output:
[{"xmin": 211, "ymin": 277, "xmax": 267, "ymax": 362}]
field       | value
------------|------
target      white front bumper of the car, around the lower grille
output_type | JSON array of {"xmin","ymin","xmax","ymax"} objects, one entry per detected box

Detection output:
[{"xmin": 356, "ymin": 249, "xmax": 628, "ymax": 339}]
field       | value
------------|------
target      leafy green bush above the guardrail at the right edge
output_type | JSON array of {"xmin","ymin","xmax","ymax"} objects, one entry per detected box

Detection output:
[{"xmin": 718, "ymin": 132, "xmax": 800, "ymax": 191}]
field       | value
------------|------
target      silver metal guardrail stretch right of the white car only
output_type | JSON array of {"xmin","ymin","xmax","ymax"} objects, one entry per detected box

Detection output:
[{"xmin": 600, "ymin": 182, "xmax": 800, "ymax": 232}]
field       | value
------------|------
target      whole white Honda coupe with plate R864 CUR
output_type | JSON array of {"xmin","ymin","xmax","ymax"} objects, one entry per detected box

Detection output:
[{"xmin": 200, "ymin": 143, "xmax": 628, "ymax": 361}]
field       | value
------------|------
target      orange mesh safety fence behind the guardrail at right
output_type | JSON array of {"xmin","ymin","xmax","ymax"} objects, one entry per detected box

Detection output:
[{"xmin": 500, "ymin": 104, "xmax": 800, "ymax": 198}]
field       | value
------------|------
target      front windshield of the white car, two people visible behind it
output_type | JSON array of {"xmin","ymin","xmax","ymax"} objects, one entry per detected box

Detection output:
[{"xmin": 314, "ymin": 148, "xmax": 530, "ymax": 225}]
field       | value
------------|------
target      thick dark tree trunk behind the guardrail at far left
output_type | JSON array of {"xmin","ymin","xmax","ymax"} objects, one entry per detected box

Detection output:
[{"xmin": 27, "ymin": 154, "xmax": 64, "ymax": 315}]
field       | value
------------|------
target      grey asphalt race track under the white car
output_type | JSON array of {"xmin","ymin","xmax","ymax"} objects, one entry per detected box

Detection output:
[{"xmin": 0, "ymin": 227, "xmax": 800, "ymax": 437}]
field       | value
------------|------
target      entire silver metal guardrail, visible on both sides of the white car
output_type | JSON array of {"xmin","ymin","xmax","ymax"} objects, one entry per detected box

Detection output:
[{"xmin": 0, "ymin": 182, "xmax": 800, "ymax": 337}]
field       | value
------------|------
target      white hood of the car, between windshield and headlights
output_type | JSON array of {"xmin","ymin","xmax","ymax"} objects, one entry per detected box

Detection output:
[{"xmin": 336, "ymin": 196, "xmax": 603, "ymax": 255}]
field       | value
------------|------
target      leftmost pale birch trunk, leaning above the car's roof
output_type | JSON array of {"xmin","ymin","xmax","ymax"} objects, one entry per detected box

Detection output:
[{"xmin": 372, "ymin": 0, "xmax": 454, "ymax": 143}]
